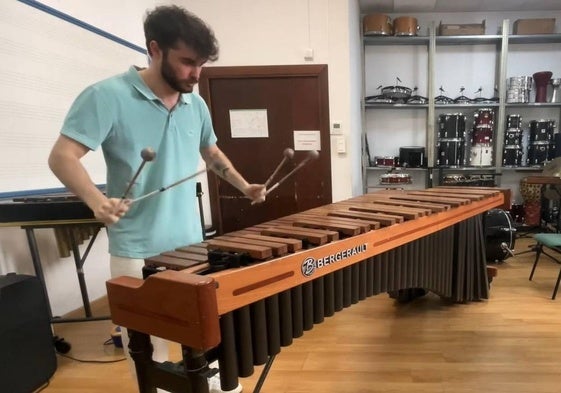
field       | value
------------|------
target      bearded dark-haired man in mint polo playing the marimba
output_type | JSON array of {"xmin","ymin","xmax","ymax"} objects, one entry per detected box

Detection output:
[{"xmin": 49, "ymin": 6, "xmax": 265, "ymax": 392}]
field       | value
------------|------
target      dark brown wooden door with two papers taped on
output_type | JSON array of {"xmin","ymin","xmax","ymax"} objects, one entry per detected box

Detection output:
[{"xmin": 199, "ymin": 65, "xmax": 332, "ymax": 234}]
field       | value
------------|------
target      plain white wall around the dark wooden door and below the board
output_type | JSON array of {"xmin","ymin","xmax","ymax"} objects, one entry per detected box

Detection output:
[{"xmin": 0, "ymin": 0, "xmax": 361, "ymax": 315}]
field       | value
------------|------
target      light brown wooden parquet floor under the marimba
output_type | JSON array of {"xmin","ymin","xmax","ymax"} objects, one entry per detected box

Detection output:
[{"xmin": 40, "ymin": 239, "xmax": 561, "ymax": 393}]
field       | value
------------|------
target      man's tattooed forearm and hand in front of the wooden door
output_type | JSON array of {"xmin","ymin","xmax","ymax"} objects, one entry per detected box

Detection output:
[{"xmin": 201, "ymin": 145, "xmax": 265, "ymax": 203}]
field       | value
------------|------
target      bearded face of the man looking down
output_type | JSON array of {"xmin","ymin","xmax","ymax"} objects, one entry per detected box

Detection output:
[{"xmin": 160, "ymin": 43, "xmax": 206, "ymax": 93}]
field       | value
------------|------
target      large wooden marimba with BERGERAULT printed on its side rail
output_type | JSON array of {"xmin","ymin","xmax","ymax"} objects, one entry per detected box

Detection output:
[{"xmin": 107, "ymin": 187, "xmax": 504, "ymax": 393}]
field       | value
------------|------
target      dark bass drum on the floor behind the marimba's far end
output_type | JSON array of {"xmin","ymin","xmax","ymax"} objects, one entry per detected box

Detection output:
[{"xmin": 484, "ymin": 209, "xmax": 516, "ymax": 262}]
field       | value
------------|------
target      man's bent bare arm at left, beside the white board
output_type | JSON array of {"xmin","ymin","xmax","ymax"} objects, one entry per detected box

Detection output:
[{"xmin": 49, "ymin": 135, "xmax": 128, "ymax": 224}]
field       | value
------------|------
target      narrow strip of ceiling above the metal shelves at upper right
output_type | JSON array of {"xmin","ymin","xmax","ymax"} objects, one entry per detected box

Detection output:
[{"xmin": 358, "ymin": 0, "xmax": 561, "ymax": 13}]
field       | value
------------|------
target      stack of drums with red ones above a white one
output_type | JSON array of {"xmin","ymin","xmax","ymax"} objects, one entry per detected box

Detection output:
[{"xmin": 470, "ymin": 108, "xmax": 495, "ymax": 166}]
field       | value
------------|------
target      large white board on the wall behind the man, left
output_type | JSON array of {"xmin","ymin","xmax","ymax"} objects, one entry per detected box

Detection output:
[{"xmin": 0, "ymin": 1, "xmax": 146, "ymax": 194}]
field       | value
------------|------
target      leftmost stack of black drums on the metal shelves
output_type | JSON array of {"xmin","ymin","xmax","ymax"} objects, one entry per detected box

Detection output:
[{"xmin": 437, "ymin": 113, "xmax": 466, "ymax": 167}]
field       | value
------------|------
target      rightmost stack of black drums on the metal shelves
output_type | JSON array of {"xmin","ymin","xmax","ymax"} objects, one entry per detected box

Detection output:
[{"xmin": 528, "ymin": 120, "xmax": 555, "ymax": 166}]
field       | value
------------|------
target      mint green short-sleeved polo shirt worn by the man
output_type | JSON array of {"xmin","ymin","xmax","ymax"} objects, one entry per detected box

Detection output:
[{"xmin": 61, "ymin": 67, "xmax": 216, "ymax": 258}]
